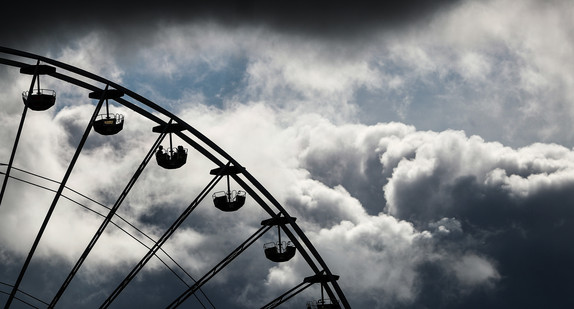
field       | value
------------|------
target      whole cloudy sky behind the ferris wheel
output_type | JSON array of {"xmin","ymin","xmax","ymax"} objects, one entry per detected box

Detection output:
[{"xmin": 0, "ymin": 0, "xmax": 574, "ymax": 308}]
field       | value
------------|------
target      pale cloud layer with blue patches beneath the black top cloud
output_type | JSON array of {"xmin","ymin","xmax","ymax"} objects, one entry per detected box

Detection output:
[{"xmin": 6, "ymin": 0, "xmax": 573, "ymax": 147}]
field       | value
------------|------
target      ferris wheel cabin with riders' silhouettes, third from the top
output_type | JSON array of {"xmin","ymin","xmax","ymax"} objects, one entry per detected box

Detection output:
[{"xmin": 152, "ymin": 123, "xmax": 187, "ymax": 170}]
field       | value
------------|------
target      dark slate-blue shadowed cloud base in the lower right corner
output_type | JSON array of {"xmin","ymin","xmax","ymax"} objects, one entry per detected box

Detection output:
[{"xmin": 412, "ymin": 177, "xmax": 574, "ymax": 308}]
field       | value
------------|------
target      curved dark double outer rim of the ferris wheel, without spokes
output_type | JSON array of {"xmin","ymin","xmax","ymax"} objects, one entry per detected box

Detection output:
[{"xmin": 0, "ymin": 46, "xmax": 351, "ymax": 308}]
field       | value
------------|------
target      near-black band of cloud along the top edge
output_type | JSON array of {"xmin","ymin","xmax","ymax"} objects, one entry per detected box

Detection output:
[{"xmin": 0, "ymin": 0, "xmax": 464, "ymax": 45}]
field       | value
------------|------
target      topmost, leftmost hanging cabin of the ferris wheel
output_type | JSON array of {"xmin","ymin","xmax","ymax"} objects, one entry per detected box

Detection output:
[{"xmin": 20, "ymin": 64, "xmax": 56, "ymax": 111}]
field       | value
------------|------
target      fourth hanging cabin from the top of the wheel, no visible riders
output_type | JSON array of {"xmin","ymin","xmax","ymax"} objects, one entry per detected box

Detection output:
[{"xmin": 209, "ymin": 166, "xmax": 246, "ymax": 212}]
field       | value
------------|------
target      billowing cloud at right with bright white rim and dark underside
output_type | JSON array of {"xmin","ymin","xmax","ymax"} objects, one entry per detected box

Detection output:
[{"xmin": 380, "ymin": 132, "xmax": 574, "ymax": 308}]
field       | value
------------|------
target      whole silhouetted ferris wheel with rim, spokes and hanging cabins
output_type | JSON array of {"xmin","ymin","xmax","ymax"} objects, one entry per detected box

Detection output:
[{"xmin": 0, "ymin": 47, "xmax": 350, "ymax": 309}]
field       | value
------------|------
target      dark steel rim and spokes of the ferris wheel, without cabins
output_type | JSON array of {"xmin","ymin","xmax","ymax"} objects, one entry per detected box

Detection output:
[{"xmin": 0, "ymin": 47, "xmax": 351, "ymax": 308}]
